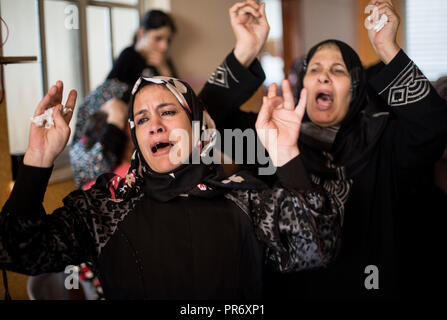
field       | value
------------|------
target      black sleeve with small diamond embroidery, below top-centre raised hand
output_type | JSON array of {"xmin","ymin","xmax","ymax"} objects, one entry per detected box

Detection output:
[{"xmin": 199, "ymin": 52, "xmax": 265, "ymax": 129}]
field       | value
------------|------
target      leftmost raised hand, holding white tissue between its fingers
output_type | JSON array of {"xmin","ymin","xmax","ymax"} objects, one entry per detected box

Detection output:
[{"xmin": 23, "ymin": 81, "xmax": 77, "ymax": 168}]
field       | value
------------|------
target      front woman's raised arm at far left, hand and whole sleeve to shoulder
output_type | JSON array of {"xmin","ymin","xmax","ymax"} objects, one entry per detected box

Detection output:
[{"xmin": 0, "ymin": 82, "xmax": 133, "ymax": 274}]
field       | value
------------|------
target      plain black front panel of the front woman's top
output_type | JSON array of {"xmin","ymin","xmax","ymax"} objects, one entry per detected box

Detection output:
[{"xmin": 98, "ymin": 197, "xmax": 263, "ymax": 299}]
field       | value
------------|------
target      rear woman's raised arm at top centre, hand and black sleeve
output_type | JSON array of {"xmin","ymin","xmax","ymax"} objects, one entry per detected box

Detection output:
[{"xmin": 199, "ymin": 0, "xmax": 270, "ymax": 129}]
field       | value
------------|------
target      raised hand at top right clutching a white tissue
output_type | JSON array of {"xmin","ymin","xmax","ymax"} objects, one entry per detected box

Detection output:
[{"xmin": 368, "ymin": 0, "xmax": 400, "ymax": 64}]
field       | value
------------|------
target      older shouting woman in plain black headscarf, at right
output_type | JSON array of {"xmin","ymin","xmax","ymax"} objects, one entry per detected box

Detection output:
[{"xmin": 209, "ymin": 1, "xmax": 447, "ymax": 299}]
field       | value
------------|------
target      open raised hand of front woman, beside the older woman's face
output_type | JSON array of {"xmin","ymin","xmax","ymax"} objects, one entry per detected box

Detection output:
[{"xmin": 256, "ymin": 80, "xmax": 307, "ymax": 167}]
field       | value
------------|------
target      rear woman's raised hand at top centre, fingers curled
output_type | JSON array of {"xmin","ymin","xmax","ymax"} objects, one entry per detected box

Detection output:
[{"xmin": 229, "ymin": 0, "xmax": 270, "ymax": 67}]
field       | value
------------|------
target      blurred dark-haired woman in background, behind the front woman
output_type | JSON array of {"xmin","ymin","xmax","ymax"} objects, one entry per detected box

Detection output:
[{"xmin": 70, "ymin": 10, "xmax": 176, "ymax": 187}]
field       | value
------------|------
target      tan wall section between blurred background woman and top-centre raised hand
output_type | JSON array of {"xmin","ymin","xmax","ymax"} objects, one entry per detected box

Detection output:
[{"xmin": 170, "ymin": 0, "xmax": 236, "ymax": 91}]
